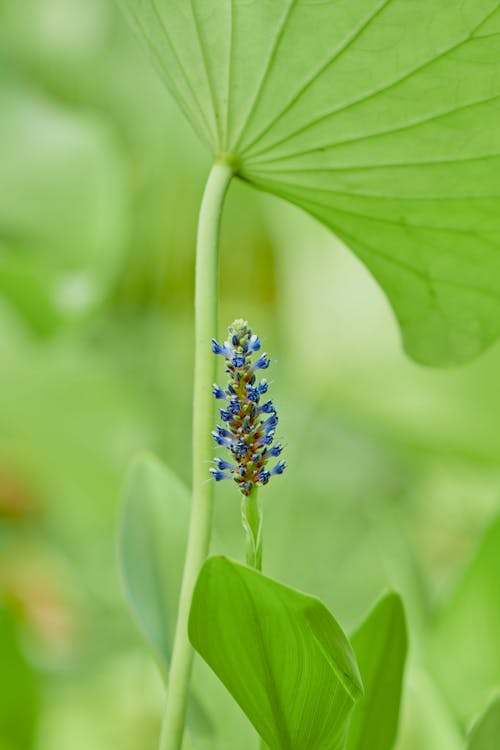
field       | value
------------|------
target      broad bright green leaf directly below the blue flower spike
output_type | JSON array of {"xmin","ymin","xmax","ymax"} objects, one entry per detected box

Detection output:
[{"xmin": 189, "ymin": 557, "xmax": 362, "ymax": 750}]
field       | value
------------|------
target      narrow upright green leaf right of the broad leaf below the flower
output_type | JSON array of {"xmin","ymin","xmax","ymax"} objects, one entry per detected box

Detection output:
[{"xmin": 346, "ymin": 593, "xmax": 408, "ymax": 750}]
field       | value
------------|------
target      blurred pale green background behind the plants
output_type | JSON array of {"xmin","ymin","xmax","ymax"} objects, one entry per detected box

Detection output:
[{"xmin": 0, "ymin": 0, "xmax": 500, "ymax": 750}]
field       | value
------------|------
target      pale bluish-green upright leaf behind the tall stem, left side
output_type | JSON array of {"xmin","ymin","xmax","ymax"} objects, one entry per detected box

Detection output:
[{"xmin": 119, "ymin": 453, "xmax": 190, "ymax": 672}]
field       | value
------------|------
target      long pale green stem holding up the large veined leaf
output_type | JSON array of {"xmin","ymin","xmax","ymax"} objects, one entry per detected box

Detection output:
[{"xmin": 160, "ymin": 163, "xmax": 232, "ymax": 750}]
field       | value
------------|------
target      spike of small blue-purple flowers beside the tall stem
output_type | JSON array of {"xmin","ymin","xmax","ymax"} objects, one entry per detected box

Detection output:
[{"xmin": 210, "ymin": 320, "xmax": 286, "ymax": 495}]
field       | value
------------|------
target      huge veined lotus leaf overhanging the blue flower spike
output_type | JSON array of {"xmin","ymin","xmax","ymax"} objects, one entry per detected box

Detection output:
[{"xmin": 121, "ymin": 0, "xmax": 500, "ymax": 364}]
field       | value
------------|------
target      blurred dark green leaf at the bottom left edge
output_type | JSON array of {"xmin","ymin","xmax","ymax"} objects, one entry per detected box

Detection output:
[{"xmin": 0, "ymin": 602, "xmax": 39, "ymax": 750}]
